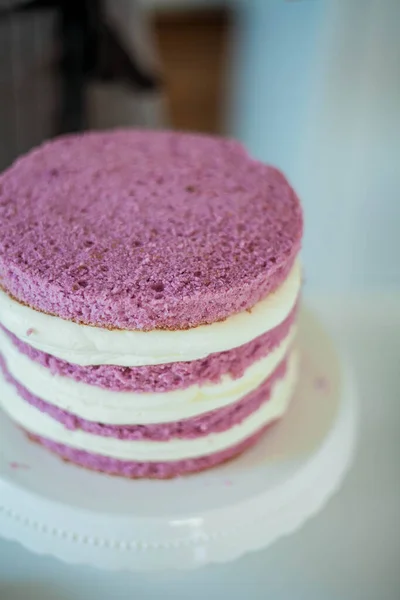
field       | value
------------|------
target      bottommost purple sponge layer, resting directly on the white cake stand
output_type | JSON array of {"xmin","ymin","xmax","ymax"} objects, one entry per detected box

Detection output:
[{"xmin": 27, "ymin": 423, "xmax": 273, "ymax": 479}]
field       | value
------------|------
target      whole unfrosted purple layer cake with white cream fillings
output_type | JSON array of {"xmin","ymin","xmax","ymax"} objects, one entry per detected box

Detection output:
[{"xmin": 0, "ymin": 130, "xmax": 303, "ymax": 478}]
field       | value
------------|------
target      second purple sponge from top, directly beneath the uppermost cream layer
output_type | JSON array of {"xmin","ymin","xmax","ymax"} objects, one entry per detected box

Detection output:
[{"xmin": 0, "ymin": 307, "xmax": 297, "ymax": 392}]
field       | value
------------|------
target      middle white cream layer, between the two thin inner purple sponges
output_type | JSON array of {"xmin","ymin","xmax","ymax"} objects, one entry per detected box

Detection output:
[{"xmin": 0, "ymin": 326, "xmax": 295, "ymax": 425}]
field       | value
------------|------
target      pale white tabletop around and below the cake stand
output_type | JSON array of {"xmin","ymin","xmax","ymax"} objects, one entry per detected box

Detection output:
[{"xmin": 0, "ymin": 293, "xmax": 400, "ymax": 600}]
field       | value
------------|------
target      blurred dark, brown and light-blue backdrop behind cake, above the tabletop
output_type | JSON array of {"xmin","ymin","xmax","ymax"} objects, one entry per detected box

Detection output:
[{"xmin": 0, "ymin": 0, "xmax": 400, "ymax": 290}]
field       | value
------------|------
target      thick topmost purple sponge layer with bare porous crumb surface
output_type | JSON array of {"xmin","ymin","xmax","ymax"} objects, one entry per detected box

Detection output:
[{"xmin": 0, "ymin": 130, "xmax": 303, "ymax": 330}]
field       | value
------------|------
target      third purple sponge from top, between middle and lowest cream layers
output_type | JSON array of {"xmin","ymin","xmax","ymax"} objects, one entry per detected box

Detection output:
[{"xmin": 0, "ymin": 354, "xmax": 287, "ymax": 441}]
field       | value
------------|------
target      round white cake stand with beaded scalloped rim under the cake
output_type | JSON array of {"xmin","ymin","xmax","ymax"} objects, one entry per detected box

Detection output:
[{"xmin": 0, "ymin": 312, "xmax": 356, "ymax": 570}]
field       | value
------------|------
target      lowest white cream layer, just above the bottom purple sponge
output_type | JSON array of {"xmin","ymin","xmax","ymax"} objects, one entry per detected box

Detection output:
[{"xmin": 0, "ymin": 353, "xmax": 298, "ymax": 462}]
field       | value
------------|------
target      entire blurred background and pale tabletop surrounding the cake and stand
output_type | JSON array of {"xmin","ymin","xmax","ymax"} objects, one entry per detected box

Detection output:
[{"xmin": 0, "ymin": 0, "xmax": 400, "ymax": 600}]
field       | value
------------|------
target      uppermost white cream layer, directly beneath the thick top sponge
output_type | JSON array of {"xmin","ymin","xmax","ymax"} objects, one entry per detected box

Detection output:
[{"xmin": 0, "ymin": 260, "xmax": 301, "ymax": 367}]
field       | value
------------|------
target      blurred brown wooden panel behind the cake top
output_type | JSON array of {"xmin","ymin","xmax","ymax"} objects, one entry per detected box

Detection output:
[{"xmin": 154, "ymin": 9, "xmax": 230, "ymax": 133}]
